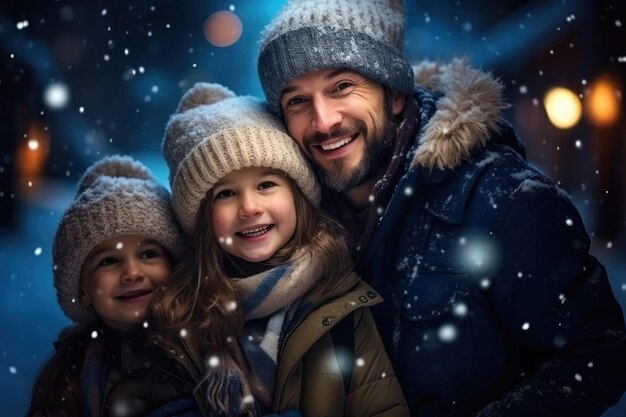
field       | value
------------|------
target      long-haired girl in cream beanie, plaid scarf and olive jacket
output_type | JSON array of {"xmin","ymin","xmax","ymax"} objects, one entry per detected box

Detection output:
[{"xmin": 152, "ymin": 84, "xmax": 408, "ymax": 416}]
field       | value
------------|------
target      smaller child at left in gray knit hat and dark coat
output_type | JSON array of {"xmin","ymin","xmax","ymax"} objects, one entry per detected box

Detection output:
[{"xmin": 28, "ymin": 156, "xmax": 195, "ymax": 417}]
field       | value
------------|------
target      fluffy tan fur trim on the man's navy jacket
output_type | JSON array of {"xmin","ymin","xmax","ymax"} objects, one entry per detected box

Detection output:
[{"xmin": 411, "ymin": 58, "xmax": 507, "ymax": 169}]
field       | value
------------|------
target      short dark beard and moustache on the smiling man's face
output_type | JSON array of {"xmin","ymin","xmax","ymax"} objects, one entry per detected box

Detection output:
[{"xmin": 313, "ymin": 108, "xmax": 395, "ymax": 193}]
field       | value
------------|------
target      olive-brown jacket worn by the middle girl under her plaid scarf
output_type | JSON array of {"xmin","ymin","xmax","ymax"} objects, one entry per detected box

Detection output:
[{"xmin": 158, "ymin": 274, "xmax": 409, "ymax": 417}]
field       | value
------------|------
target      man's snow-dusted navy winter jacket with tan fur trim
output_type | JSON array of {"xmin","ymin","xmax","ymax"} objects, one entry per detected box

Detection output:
[{"xmin": 326, "ymin": 61, "xmax": 626, "ymax": 416}]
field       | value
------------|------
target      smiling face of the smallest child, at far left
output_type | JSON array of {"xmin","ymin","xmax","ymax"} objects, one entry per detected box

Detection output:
[{"xmin": 81, "ymin": 236, "xmax": 170, "ymax": 331}]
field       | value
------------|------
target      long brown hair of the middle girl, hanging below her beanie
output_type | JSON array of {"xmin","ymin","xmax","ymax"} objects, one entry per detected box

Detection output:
[{"xmin": 148, "ymin": 172, "xmax": 353, "ymax": 351}]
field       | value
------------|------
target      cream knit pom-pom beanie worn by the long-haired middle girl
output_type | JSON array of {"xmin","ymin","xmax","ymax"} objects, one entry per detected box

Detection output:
[{"xmin": 162, "ymin": 83, "xmax": 321, "ymax": 233}]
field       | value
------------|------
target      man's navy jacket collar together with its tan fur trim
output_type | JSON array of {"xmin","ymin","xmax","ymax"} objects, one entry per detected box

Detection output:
[{"xmin": 398, "ymin": 59, "xmax": 525, "ymax": 224}]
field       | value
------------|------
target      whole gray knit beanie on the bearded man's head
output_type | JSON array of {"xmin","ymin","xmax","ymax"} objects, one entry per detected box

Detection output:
[{"xmin": 258, "ymin": 0, "xmax": 414, "ymax": 115}]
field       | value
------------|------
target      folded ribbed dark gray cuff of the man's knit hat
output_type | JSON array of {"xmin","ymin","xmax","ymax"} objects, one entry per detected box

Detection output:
[{"xmin": 258, "ymin": 27, "xmax": 415, "ymax": 115}]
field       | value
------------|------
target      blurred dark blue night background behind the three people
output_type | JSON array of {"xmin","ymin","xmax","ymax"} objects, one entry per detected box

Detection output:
[{"xmin": 0, "ymin": 0, "xmax": 626, "ymax": 416}]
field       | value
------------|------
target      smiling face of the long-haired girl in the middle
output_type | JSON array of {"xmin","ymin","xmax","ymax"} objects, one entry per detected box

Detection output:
[{"xmin": 211, "ymin": 167, "xmax": 296, "ymax": 262}]
